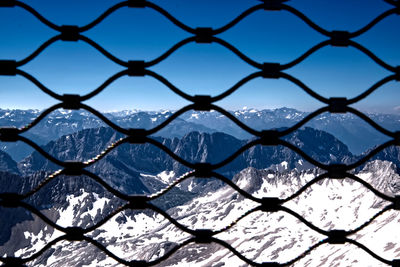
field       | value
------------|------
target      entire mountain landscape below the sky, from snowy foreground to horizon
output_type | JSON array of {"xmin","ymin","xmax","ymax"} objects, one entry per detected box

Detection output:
[{"xmin": 0, "ymin": 108, "xmax": 400, "ymax": 266}]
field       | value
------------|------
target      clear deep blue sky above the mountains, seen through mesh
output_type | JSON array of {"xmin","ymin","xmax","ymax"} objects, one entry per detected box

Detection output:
[{"xmin": 0, "ymin": 0, "xmax": 400, "ymax": 113}]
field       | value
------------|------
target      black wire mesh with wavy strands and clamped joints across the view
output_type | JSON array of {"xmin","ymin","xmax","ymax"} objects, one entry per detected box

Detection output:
[{"xmin": 0, "ymin": 0, "xmax": 400, "ymax": 266}]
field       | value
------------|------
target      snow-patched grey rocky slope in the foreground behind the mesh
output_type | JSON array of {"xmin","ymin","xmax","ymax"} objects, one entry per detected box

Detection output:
[{"xmin": 0, "ymin": 161, "xmax": 400, "ymax": 266}]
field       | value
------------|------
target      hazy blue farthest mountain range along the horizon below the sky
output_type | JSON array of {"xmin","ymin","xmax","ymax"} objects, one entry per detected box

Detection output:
[{"xmin": 0, "ymin": 108, "xmax": 400, "ymax": 161}]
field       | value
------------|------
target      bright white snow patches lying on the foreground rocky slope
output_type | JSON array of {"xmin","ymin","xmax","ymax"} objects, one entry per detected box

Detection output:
[{"xmin": 10, "ymin": 161, "xmax": 400, "ymax": 267}]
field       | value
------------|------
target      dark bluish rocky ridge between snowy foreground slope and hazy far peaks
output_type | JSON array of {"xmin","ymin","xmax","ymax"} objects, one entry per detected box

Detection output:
[{"xmin": 18, "ymin": 127, "xmax": 353, "ymax": 191}]
